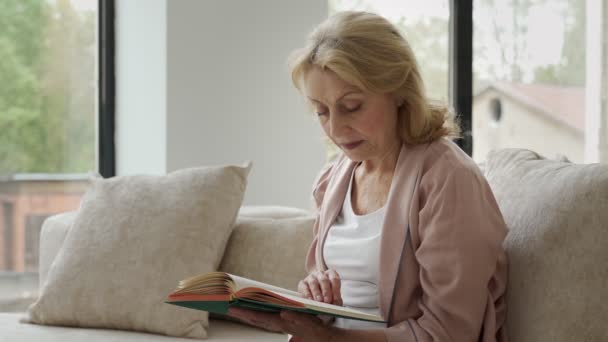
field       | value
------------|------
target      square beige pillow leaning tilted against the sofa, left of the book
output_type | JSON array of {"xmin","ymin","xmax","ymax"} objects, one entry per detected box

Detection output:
[{"xmin": 25, "ymin": 166, "xmax": 249, "ymax": 338}]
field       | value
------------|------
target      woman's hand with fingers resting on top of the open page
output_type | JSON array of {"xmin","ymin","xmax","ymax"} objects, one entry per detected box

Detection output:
[{"xmin": 298, "ymin": 270, "xmax": 342, "ymax": 306}]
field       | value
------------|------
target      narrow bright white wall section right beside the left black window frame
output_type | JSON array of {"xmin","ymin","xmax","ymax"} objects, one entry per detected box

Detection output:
[{"xmin": 115, "ymin": 0, "xmax": 167, "ymax": 175}]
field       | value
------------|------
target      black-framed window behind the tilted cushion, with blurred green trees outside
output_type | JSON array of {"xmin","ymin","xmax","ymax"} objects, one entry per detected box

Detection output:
[{"xmin": 0, "ymin": 0, "xmax": 113, "ymax": 311}]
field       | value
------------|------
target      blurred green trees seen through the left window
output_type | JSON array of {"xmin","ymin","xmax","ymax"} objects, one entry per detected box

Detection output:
[{"xmin": 0, "ymin": 0, "xmax": 96, "ymax": 174}]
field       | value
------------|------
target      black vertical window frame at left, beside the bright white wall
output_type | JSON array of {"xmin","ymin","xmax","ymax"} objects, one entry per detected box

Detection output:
[{"xmin": 97, "ymin": 0, "xmax": 116, "ymax": 178}]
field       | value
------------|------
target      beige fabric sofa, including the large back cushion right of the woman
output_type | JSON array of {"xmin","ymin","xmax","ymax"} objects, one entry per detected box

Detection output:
[{"xmin": 0, "ymin": 149, "xmax": 608, "ymax": 342}]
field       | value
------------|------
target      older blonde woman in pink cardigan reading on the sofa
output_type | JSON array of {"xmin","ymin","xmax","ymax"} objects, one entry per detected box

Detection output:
[{"xmin": 231, "ymin": 12, "xmax": 507, "ymax": 342}]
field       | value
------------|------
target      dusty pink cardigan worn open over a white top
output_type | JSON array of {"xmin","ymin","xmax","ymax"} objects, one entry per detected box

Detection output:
[{"xmin": 306, "ymin": 138, "xmax": 508, "ymax": 342}]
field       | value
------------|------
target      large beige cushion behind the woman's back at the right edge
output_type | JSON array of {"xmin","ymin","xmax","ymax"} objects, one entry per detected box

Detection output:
[{"xmin": 486, "ymin": 149, "xmax": 608, "ymax": 342}]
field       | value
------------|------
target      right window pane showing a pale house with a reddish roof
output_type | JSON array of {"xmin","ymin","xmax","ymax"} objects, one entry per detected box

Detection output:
[{"xmin": 473, "ymin": 0, "xmax": 600, "ymax": 162}]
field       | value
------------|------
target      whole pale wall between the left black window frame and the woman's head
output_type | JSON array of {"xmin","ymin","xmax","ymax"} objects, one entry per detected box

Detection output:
[{"xmin": 117, "ymin": 0, "xmax": 327, "ymax": 208}]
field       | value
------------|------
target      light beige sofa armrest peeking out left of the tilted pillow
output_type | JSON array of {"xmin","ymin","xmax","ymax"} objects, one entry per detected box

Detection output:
[{"xmin": 38, "ymin": 211, "xmax": 76, "ymax": 288}]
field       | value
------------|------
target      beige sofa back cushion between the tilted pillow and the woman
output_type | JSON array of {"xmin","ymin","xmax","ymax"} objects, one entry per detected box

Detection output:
[{"xmin": 220, "ymin": 214, "xmax": 315, "ymax": 290}]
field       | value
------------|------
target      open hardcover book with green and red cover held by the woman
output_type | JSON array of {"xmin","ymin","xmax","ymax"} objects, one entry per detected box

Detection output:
[{"xmin": 166, "ymin": 272, "xmax": 385, "ymax": 322}]
